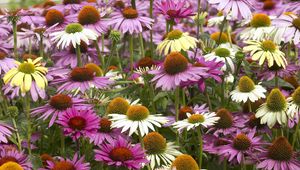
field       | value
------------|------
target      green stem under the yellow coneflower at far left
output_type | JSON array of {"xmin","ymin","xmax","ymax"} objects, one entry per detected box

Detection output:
[{"xmin": 24, "ymin": 93, "xmax": 31, "ymax": 155}]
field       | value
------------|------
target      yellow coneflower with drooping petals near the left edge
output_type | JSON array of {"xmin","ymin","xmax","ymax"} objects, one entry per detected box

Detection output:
[{"xmin": 3, "ymin": 57, "xmax": 48, "ymax": 93}]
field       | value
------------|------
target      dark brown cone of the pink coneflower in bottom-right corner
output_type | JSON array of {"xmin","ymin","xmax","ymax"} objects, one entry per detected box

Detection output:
[{"xmin": 268, "ymin": 137, "xmax": 293, "ymax": 161}]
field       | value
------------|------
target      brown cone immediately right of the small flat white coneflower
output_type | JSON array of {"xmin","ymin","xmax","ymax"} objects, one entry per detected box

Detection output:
[{"xmin": 215, "ymin": 108, "xmax": 233, "ymax": 129}]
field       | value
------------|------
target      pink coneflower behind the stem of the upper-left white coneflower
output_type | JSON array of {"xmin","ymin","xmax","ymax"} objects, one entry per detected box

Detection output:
[{"xmin": 51, "ymin": 41, "xmax": 99, "ymax": 68}]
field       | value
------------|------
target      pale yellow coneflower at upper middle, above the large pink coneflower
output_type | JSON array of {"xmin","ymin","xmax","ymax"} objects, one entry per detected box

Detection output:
[{"xmin": 157, "ymin": 30, "xmax": 198, "ymax": 55}]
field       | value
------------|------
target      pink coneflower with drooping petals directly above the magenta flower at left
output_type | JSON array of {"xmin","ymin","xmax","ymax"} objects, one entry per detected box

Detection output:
[{"xmin": 31, "ymin": 94, "xmax": 92, "ymax": 127}]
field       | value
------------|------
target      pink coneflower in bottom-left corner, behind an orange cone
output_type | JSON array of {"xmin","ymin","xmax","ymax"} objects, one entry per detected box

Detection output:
[{"xmin": 0, "ymin": 146, "xmax": 32, "ymax": 170}]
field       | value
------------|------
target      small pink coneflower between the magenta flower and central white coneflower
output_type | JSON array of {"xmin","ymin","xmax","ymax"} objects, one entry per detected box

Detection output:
[{"xmin": 89, "ymin": 118, "xmax": 122, "ymax": 146}]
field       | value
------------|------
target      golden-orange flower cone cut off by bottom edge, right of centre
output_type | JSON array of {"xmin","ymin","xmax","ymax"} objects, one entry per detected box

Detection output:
[{"xmin": 171, "ymin": 154, "xmax": 200, "ymax": 170}]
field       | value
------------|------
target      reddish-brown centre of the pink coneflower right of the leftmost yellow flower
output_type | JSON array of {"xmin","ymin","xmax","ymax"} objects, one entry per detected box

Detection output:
[{"xmin": 70, "ymin": 67, "xmax": 95, "ymax": 82}]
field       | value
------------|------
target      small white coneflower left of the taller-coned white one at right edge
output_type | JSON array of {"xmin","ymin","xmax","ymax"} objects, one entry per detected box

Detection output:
[{"xmin": 230, "ymin": 76, "xmax": 267, "ymax": 103}]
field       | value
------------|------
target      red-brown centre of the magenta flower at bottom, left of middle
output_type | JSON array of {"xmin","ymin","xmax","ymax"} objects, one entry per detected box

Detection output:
[{"xmin": 109, "ymin": 147, "xmax": 133, "ymax": 161}]
